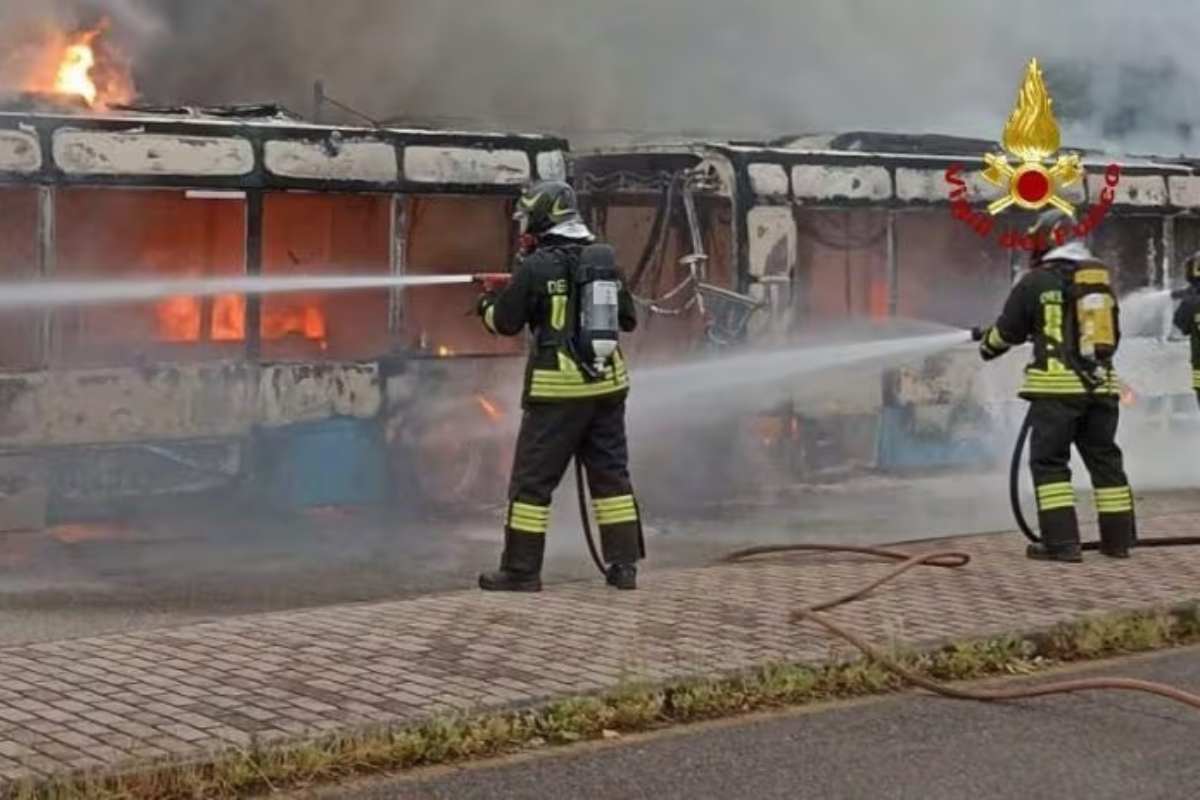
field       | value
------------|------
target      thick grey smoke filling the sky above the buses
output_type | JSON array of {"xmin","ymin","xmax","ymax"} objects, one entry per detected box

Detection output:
[{"xmin": 0, "ymin": 0, "xmax": 1200, "ymax": 152}]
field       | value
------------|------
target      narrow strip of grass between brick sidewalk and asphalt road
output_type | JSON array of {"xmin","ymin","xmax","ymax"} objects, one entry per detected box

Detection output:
[{"xmin": 7, "ymin": 603, "xmax": 1200, "ymax": 800}]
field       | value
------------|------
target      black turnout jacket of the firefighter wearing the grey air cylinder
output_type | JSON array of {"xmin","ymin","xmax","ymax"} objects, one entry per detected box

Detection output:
[{"xmin": 481, "ymin": 240, "xmax": 637, "ymax": 404}]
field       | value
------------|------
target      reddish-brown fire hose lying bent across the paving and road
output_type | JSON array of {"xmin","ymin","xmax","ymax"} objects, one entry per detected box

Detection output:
[{"xmin": 721, "ymin": 545, "xmax": 1200, "ymax": 710}]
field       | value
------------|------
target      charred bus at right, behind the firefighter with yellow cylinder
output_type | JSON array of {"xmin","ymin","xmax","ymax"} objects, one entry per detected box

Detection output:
[{"xmin": 572, "ymin": 132, "xmax": 1200, "ymax": 484}]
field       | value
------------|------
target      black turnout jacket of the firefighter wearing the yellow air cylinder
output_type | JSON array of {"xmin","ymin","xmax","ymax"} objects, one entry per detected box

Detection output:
[{"xmin": 979, "ymin": 245, "xmax": 1120, "ymax": 399}]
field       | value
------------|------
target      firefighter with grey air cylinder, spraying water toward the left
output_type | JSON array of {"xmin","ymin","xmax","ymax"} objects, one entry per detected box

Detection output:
[{"xmin": 478, "ymin": 181, "xmax": 644, "ymax": 591}]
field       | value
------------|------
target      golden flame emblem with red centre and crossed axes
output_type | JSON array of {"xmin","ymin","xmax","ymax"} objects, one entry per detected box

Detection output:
[{"xmin": 983, "ymin": 59, "xmax": 1084, "ymax": 216}]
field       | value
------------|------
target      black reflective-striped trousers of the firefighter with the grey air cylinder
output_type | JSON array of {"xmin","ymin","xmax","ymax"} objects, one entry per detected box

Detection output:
[{"xmin": 500, "ymin": 395, "xmax": 646, "ymax": 575}]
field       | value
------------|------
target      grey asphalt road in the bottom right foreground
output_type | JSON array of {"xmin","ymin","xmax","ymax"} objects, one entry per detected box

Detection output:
[{"xmin": 307, "ymin": 649, "xmax": 1200, "ymax": 800}]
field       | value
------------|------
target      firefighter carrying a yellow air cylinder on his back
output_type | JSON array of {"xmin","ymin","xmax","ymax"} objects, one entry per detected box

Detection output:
[{"xmin": 980, "ymin": 211, "xmax": 1135, "ymax": 561}]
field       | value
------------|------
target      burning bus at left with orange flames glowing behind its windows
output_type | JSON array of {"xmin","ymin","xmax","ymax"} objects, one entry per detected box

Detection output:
[{"xmin": 0, "ymin": 107, "xmax": 566, "ymax": 529}]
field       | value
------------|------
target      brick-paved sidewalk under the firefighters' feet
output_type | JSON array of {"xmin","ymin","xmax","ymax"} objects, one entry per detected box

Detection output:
[{"xmin": 0, "ymin": 515, "xmax": 1200, "ymax": 781}]
